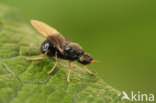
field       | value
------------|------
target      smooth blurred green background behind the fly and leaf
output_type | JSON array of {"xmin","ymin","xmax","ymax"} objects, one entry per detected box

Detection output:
[{"xmin": 0, "ymin": 0, "xmax": 156, "ymax": 103}]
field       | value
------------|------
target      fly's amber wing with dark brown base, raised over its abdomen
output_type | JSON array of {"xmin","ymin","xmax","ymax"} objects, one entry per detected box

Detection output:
[{"xmin": 31, "ymin": 20, "xmax": 71, "ymax": 52}]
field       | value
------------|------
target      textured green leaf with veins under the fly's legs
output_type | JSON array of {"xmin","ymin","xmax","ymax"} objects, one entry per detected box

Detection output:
[{"xmin": 0, "ymin": 5, "xmax": 123, "ymax": 103}]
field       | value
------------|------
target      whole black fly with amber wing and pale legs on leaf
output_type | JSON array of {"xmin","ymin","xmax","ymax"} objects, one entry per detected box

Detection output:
[{"xmin": 27, "ymin": 20, "xmax": 95, "ymax": 82}]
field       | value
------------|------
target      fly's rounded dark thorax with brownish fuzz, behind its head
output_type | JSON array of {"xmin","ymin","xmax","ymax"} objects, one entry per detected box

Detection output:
[{"xmin": 64, "ymin": 43, "xmax": 84, "ymax": 58}]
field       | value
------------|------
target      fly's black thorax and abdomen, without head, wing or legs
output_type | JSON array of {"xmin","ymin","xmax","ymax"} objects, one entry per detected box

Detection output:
[{"xmin": 40, "ymin": 39, "xmax": 84, "ymax": 61}]
